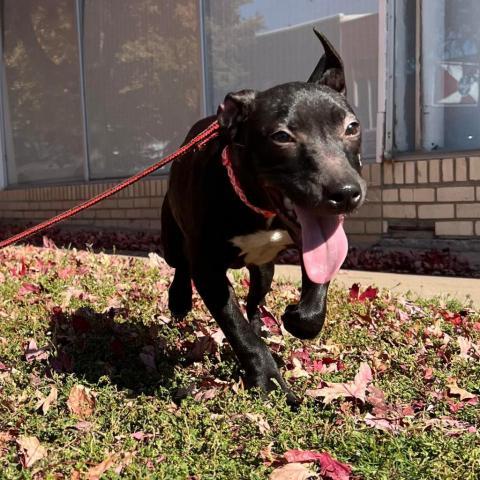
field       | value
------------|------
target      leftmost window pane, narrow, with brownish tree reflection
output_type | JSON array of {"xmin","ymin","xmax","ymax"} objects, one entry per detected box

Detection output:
[{"xmin": 2, "ymin": 0, "xmax": 84, "ymax": 184}]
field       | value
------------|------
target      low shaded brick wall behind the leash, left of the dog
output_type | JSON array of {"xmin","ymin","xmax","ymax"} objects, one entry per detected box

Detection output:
[{"xmin": 0, "ymin": 177, "xmax": 167, "ymax": 231}]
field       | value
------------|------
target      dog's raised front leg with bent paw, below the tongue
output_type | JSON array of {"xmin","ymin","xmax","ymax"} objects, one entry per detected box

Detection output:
[{"xmin": 282, "ymin": 264, "xmax": 329, "ymax": 340}]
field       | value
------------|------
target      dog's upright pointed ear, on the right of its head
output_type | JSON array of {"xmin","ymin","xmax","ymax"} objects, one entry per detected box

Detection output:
[{"xmin": 307, "ymin": 27, "xmax": 347, "ymax": 95}]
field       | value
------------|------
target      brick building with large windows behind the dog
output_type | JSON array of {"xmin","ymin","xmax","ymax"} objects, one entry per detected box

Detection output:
[{"xmin": 0, "ymin": 0, "xmax": 480, "ymax": 258}]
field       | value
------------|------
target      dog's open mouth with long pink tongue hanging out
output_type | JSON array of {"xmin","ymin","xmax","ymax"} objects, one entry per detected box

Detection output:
[{"xmin": 269, "ymin": 191, "xmax": 348, "ymax": 283}]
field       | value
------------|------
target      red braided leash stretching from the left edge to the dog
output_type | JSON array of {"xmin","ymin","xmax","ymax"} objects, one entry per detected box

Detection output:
[{"xmin": 0, "ymin": 121, "xmax": 220, "ymax": 249}]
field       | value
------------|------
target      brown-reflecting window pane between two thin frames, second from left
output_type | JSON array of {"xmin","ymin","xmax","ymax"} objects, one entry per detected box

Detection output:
[{"xmin": 84, "ymin": 0, "xmax": 203, "ymax": 178}]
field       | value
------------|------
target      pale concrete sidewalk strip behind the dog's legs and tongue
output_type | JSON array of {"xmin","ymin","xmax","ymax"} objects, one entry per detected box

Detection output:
[{"xmin": 275, "ymin": 265, "xmax": 480, "ymax": 308}]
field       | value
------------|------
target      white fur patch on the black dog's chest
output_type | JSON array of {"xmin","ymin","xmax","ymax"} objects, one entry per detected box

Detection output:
[{"xmin": 230, "ymin": 230, "xmax": 293, "ymax": 265}]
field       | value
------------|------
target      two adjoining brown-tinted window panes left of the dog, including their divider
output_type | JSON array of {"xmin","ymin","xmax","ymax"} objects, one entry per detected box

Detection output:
[{"xmin": 0, "ymin": 0, "xmax": 204, "ymax": 185}]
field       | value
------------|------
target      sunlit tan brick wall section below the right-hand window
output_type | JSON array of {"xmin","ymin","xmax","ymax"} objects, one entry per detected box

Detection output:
[{"xmin": 382, "ymin": 157, "xmax": 480, "ymax": 237}]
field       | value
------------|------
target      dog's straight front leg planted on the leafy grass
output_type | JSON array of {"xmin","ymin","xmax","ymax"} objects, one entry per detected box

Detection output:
[{"xmin": 193, "ymin": 265, "xmax": 298, "ymax": 404}]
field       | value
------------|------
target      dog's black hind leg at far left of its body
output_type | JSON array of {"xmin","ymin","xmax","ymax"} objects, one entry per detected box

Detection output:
[{"xmin": 162, "ymin": 195, "xmax": 192, "ymax": 319}]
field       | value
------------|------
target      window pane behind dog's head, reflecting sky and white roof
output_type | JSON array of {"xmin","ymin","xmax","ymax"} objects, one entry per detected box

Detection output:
[{"xmin": 205, "ymin": 0, "xmax": 378, "ymax": 157}]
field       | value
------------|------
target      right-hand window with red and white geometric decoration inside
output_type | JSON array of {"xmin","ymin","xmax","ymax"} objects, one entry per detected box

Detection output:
[{"xmin": 393, "ymin": 0, "xmax": 480, "ymax": 152}]
